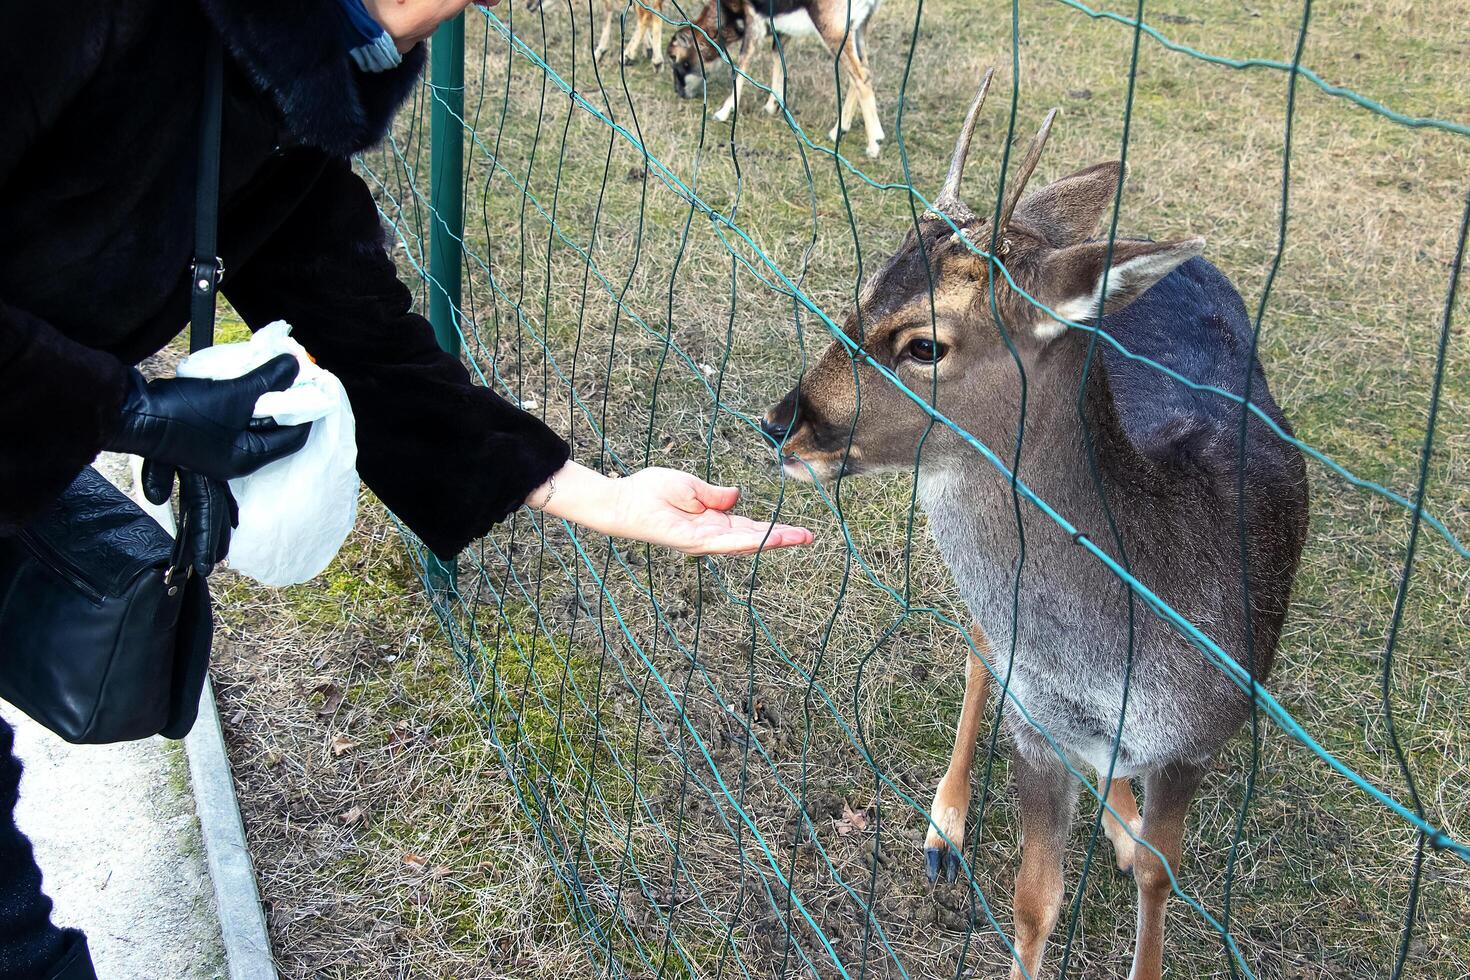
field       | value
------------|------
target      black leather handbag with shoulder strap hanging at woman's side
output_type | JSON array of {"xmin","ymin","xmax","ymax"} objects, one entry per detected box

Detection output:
[{"xmin": 0, "ymin": 38, "xmax": 223, "ymax": 743}]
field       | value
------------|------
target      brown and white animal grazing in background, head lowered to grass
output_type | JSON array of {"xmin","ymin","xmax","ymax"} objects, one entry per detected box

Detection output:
[{"xmin": 669, "ymin": 0, "xmax": 885, "ymax": 157}]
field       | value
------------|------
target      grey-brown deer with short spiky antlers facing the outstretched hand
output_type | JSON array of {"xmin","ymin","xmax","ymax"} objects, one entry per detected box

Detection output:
[{"xmin": 764, "ymin": 75, "xmax": 1307, "ymax": 980}]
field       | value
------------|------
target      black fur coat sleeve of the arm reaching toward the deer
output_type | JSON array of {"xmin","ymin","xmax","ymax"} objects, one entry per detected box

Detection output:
[{"xmin": 225, "ymin": 160, "xmax": 569, "ymax": 557}]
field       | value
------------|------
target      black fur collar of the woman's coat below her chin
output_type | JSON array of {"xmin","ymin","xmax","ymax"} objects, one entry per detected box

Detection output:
[{"xmin": 200, "ymin": 0, "xmax": 425, "ymax": 156}]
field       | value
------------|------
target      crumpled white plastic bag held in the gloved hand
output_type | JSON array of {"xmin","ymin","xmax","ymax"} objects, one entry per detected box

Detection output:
[{"xmin": 178, "ymin": 320, "xmax": 357, "ymax": 585}]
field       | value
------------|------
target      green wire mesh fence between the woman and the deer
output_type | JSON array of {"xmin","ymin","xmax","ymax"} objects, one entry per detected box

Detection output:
[{"xmin": 360, "ymin": 0, "xmax": 1470, "ymax": 977}]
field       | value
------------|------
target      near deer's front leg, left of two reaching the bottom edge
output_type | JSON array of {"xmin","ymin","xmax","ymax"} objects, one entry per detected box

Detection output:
[{"xmin": 1010, "ymin": 746, "xmax": 1078, "ymax": 980}]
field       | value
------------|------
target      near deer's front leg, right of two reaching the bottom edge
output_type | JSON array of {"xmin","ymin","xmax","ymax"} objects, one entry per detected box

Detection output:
[{"xmin": 1129, "ymin": 764, "xmax": 1204, "ymax": 980}]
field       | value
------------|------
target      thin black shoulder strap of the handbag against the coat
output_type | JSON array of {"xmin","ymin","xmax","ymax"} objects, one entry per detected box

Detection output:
[{"xmin": 188, "ymin": 31, "xmax": 225, "ymax": 351}]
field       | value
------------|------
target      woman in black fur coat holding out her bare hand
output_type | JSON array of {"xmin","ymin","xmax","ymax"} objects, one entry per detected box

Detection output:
[{"xmin": 0, "ymin": 0, "xmax": 810, "ymax": 980}]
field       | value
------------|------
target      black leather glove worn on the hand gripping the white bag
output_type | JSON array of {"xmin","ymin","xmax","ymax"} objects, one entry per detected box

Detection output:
[{"xmin": 104, "ymin": 354, "xmax": 312, "ymax": 487}]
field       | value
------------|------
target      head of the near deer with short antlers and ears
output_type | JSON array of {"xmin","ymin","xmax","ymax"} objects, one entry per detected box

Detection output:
[{"xmin": 761, "ymin": 72, "xmax": 1204, "ymax": 480}]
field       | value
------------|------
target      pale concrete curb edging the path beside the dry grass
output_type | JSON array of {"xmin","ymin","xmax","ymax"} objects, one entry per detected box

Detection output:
[{"xmin": 184, "ymin": 680, "xmax": 279, "ymax": 980}]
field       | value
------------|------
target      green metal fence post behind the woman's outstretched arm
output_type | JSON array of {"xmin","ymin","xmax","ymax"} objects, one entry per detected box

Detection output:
[{"xmin": 428, "ymin": 13, "xmax": 465, "ymax": 592}]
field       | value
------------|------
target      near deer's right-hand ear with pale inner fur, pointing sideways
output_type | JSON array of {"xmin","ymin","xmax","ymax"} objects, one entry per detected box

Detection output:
[{"xmin": 1036, "ymin": 238, "xmax": 1204, "ymax": 341}]
